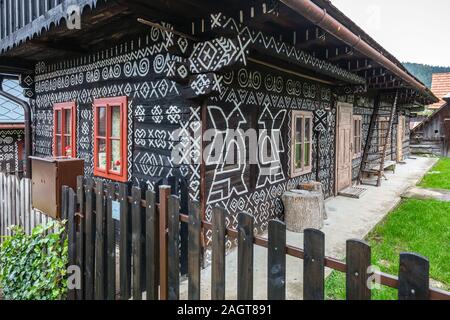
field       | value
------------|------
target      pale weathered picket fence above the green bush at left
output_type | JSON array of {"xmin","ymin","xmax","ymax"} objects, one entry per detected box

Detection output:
[{"xmin": 0, "ymin": 173, "xmax": 51, "ymax": 242}]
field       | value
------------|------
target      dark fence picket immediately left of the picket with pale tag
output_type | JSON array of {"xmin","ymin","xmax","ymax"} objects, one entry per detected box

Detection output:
[{"xmin": 94, "ymin": 179, "xmax": 106, "ymax": 300}]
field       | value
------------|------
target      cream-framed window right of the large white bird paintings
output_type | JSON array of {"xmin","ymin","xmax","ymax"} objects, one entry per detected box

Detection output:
[{"xmin": 291, "ymin": 111, "xmax": 313, "ymax": 177}]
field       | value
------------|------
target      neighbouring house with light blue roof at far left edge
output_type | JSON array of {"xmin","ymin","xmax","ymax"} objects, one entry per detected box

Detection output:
[{"xmin": 0, "ymin": 80, "xmax": 25, "ymax": 174}]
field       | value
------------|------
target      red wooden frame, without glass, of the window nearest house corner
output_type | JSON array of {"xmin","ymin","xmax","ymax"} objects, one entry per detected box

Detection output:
[{"xmin": 93, "ymin": 97, "xmax": 128, "ymax": 182}]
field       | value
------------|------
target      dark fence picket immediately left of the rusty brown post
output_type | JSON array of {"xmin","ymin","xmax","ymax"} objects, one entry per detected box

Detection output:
[{"xmin": 145, "ymin": 190, "xmax": 159, "ymax": 300}]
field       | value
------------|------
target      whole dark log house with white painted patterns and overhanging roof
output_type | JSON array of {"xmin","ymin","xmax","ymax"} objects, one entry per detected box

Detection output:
[{"xmin": 0, "ymin": 0, "xmax": 437, "ymax": 236}]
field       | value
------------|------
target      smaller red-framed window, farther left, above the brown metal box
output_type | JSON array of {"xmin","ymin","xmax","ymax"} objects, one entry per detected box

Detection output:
[{"xmin": 53, "ymin": 102, "xmax": 77, "ymax": 158}]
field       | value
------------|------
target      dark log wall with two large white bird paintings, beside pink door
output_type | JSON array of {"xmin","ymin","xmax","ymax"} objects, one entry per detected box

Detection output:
[{"xmin": 206, "ymin": 64, "xmax": 336, "ymax": 245}]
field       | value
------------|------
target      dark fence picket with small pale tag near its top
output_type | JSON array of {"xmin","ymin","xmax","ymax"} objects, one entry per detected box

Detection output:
[{"xmin": 106, "ymin": 182, "xmax": 116, "ymax": 300}]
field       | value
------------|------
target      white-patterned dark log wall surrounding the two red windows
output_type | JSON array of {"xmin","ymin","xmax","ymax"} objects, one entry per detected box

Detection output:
[{"xmin": 33, "ymin": 28, "xmax": 200, "ymax": 199}]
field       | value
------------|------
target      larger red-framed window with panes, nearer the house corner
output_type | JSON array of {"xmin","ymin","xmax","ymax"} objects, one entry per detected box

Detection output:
[{"xmin": 94, "ymin": 97, "xmax": 128, "ymax": 182}]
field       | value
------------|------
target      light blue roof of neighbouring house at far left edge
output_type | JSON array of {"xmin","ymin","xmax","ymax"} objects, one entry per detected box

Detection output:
[{"xmin": 0, "ymin": 80, "xmax": 26, "ymax": 124}]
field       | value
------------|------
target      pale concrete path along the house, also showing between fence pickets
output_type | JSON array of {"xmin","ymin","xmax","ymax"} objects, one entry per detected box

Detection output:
[{"xmin": 180, "ymin": 158, "xmax": 437, "ymax": 300}]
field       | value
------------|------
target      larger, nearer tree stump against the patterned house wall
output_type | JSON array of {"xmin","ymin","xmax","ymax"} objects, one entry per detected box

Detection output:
[{"xmin": 282, "ymin": 190, "xmax": 325, "ymax": 233}]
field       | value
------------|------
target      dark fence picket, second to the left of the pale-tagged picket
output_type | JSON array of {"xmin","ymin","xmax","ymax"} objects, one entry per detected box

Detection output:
[{"xmin": 84, "ymin": 178, "xmax": 96, "ymax": 300}]
